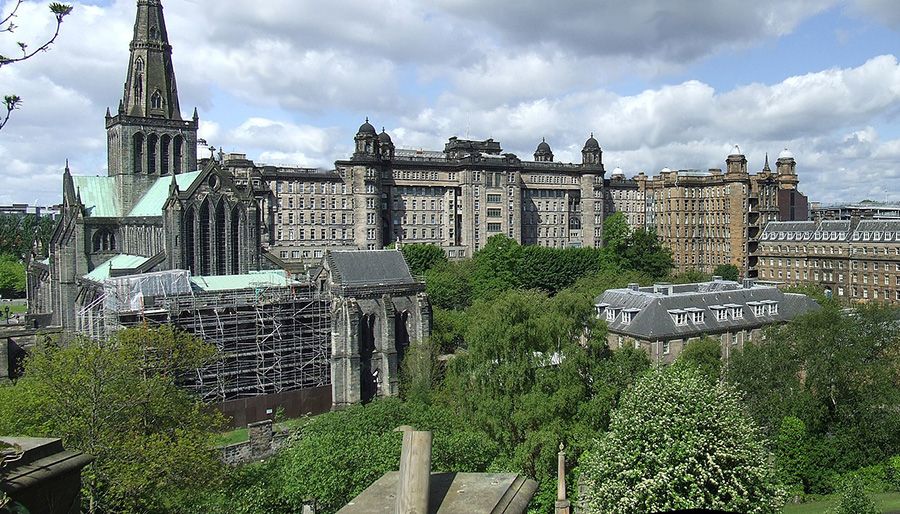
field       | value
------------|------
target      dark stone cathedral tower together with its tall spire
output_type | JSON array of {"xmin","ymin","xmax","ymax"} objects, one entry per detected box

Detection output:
[{"xmin": 106, "ymin": 0, "xmax": 198, "ymax": 212}]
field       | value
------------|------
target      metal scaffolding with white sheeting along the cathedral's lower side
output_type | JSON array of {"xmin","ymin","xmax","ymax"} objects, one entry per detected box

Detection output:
[{"xmin": 80, "ymin": 271, "xmax": 331, "ymax": 402}]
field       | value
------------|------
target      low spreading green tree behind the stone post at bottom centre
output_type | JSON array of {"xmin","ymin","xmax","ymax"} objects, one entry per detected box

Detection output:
[{"xmin": 184, "ymin": 398, "xmax": 498, "ymax": 514}]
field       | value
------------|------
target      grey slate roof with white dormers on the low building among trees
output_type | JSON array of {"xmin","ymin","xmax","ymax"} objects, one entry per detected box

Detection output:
[{"xmin": 595, "ymin": 280, "xmax": 819, "ymax": 340}]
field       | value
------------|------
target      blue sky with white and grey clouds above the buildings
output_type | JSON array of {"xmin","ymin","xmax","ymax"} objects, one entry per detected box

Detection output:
[{"xmin": 0, "ymin": 0, "xmax": 900, "ymax": 205}]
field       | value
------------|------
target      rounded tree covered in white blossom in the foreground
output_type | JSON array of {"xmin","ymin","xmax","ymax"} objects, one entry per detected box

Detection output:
[{"xmin": 581, "ymin": 366, "xmax": 782, "ymax": 513}]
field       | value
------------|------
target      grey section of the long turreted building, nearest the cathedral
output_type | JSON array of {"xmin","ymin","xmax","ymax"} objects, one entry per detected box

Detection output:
[{"xmin": 243, "ymin": 124, "xmax": 605, "ymax": 263}]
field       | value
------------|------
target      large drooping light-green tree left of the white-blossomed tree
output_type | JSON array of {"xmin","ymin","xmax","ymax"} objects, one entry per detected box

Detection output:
[{"xmin": 438, "ymin": 290, "xmax": 649, "ymax": 511}]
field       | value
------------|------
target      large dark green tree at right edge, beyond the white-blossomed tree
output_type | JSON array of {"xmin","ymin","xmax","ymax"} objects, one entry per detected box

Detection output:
[{"xmin": 726, "ymin": 305, "xmax": 900, "ymax": 493}]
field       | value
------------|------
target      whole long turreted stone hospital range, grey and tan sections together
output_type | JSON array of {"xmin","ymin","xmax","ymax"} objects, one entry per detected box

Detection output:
[{"xmin": 253, "ymin": 132, "xmax": 807, "ymax": 277}]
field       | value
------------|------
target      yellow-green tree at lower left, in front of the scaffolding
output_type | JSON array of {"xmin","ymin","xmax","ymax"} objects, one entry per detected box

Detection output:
[{"xmin": 0, "ymin": 327, "xmax": 222, "ymax": 512}]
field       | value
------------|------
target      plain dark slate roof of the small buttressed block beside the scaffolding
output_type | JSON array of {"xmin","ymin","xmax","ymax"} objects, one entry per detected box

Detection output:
[{"xmin": 325, "ymin": 250, "xmax": 416, "ymax": 286}]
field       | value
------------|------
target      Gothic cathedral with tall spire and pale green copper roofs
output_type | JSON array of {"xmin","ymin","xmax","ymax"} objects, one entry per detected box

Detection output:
[{"xmin": 28, "ymin": 0, "xmax": 277, "ymax": 328}]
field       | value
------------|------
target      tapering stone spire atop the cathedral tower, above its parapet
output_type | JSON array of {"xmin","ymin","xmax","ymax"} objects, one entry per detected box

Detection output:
[{"xmin": 123, "ymin": 0, "xmax": 181, "ymax": 120}]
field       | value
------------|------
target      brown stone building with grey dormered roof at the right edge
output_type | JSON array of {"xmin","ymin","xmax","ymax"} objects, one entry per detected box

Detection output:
[{"xmin": 758, "ymin": 217, "xmax": 900, "ymax": 304}]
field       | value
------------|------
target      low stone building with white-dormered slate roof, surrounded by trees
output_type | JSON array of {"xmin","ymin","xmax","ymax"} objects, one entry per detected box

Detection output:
[{"xmin": 595, "ymin": 277, "xmax": 819, "ymax": 364}]
